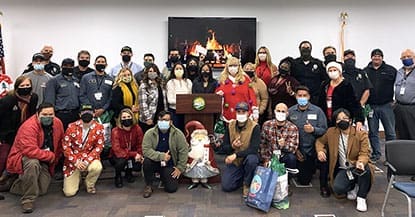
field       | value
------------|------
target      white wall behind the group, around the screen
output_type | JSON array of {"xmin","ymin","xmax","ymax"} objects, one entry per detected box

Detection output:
[{"xmin": 0, "ymin": 0, "xmax": 415, "ymax": 78}]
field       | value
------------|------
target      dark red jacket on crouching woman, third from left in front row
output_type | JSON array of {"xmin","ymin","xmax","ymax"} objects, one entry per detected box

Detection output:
[{"xmin": 111, "ymin": 124, "xmax": 143, "ymax": 159}]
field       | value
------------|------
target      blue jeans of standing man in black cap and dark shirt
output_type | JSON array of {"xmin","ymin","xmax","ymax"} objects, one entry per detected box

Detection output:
[{"xmin": 368, "ymin": 103, "xmax": 396, "ymax": 159}]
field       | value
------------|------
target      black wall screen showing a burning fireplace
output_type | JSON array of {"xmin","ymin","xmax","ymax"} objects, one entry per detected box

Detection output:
[{"xmin": 168, "ymin": 17, "xmax": 256, "ymax": 68}]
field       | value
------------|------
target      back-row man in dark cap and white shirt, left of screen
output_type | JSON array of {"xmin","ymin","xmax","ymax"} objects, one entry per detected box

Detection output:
[{"xmin": 109, "ymin": 46, "xmax": 144, "ymax": 78}]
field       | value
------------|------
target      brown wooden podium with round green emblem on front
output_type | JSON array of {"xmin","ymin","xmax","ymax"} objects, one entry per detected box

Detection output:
[{"xmin": 176, "ymin": 93, "xmax": 222, "ymax": 134}]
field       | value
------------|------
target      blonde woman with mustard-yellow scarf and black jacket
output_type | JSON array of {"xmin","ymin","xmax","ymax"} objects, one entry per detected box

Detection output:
[{"xmin": 111, "ymin": 68, "xmax": 140, "ymax": 119}]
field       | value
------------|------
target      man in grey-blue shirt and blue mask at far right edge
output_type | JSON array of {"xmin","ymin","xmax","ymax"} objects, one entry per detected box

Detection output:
[{"xmin": 394, "ymin": 49, "xmax": 415, "ymax": 140}]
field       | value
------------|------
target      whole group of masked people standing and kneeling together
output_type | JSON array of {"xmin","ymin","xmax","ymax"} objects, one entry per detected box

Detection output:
[{"xmin": 0, "ymin": 41, "xmax": 415, "ymax": 213}]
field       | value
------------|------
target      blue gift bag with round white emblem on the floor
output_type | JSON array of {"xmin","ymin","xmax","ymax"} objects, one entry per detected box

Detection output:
[{"xmin": 246, "ymin": 166, "xmax": 278, "ymax": 212}]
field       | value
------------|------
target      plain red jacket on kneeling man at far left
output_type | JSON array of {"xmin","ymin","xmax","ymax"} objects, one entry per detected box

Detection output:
[{"xmin": 7, "ymin": 115, "xmax": 64, "ymax": 174}]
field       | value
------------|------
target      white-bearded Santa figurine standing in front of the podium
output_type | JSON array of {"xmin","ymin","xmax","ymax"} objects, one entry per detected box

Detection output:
[{"xmin": 183, "ymin": 129, "xmax": 219, "ymax": 189}]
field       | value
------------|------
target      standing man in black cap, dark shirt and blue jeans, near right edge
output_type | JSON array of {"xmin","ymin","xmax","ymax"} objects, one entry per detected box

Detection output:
[{"xmin": 364, "ymin": 49, "xmax": 397, "ymax": 161}]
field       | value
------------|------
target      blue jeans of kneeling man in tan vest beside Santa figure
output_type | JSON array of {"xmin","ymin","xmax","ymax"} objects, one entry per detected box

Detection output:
[{"xmin": 221, "ymin": 154, "xmax": 259, "ymax": 192}]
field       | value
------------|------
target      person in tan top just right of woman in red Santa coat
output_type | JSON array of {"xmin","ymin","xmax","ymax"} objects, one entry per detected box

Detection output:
[{"xmin": 243, "ymin": 62, "xmax": 268, "ymax": 126}]
